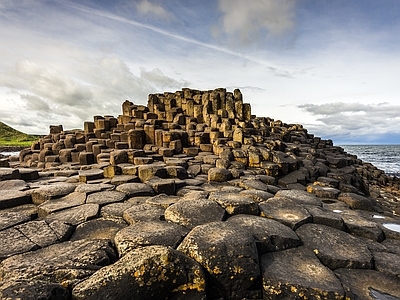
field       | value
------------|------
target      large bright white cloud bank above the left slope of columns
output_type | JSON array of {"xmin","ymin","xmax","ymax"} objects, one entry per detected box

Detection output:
[{"xmin": 0, "ymin": 53, "xmax": 192, "ymax": 133}]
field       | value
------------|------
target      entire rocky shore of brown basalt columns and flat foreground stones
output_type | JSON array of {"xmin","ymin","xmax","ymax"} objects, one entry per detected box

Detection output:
[{"xmin": 0, "ymin": 88, "xmax": 400, "ymax": 300}]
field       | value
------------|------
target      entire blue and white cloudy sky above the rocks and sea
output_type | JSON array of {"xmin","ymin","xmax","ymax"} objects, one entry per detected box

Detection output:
[{"xmin": 0, "ymin": 0, "xmax": 400, "ymax": 145}]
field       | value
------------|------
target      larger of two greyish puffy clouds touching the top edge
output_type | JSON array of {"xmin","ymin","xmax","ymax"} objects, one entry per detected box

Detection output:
[{"xmin": 217, "ymin": 0, "xmax": 295, "ymax": 43}]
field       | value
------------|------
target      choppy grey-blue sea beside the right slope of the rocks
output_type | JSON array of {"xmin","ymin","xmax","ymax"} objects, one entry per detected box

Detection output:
[{"xmin": 340, "ymin": 145, "xmax": 400, "ymax": 177}]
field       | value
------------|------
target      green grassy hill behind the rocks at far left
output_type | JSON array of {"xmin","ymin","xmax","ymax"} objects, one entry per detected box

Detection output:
[{"xmin": 0, "ymin": 122, "xmax": 41, "ymax": 147}]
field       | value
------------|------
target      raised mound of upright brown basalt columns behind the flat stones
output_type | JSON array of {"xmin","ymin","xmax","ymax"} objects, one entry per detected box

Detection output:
[{"xmin": 20, "ymin": 88, "xmax": 322, "ymax": 182}]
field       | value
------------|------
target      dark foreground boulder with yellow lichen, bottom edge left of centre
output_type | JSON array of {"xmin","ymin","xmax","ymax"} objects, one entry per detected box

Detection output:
[{"xmin": 72, "ymin": 246, "xmax": 206, "ymax": 300}]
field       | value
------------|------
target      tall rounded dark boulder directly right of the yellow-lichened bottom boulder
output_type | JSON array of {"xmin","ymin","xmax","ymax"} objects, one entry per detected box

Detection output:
[{"xmin": 178, "ymin": 222, "xmax": 261, "ymax": 299}]
